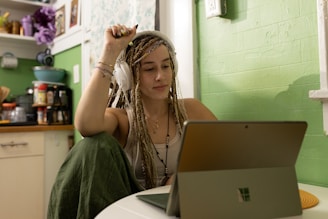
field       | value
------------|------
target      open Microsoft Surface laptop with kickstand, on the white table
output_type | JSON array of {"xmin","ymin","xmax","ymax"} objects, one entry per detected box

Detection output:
[{"xmin": 137, "ymin": 121, "xmax": 307, "ymax": 219}]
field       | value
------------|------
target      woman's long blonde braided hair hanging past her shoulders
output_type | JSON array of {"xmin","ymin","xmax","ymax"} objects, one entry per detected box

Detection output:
[{"xmin": 109, "ymin": 31, "xmax": 187, "ymax": 189}]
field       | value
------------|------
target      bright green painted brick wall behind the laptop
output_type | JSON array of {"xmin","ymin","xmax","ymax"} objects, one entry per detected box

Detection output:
[{"xmin": 196, "ymin": 0, "xmax": 328, "ymax": 186}]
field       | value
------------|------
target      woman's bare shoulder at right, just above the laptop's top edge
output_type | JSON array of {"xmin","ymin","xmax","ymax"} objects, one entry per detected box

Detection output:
[{"xmin": 180, "ymin": 98, "xmax": 217, "ymax": 120}]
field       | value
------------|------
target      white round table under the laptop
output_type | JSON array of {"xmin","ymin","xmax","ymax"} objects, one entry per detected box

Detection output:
[{"xmin": 96, "ymin": 184, "xmax": 328, "ymax": 219}]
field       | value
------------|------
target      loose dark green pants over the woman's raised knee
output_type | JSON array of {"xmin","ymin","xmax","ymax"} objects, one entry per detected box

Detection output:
[{"xmin": 48, "ymin": 133, "xmax": 141, "ymax": 219}]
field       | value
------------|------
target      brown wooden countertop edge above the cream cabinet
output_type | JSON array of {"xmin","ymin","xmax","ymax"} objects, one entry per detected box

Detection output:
[{"xmin": 0, "ymin": 125, "xmax": 74, "ymax": 133}]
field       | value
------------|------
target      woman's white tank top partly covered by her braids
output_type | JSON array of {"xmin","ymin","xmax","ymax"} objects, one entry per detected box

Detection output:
[{"xmin": 124, "ymin": 109, "xmax": 181, "ymax": 187}]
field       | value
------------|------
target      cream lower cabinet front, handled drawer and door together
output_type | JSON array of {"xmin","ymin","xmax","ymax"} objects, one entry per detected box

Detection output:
[{"xmin": 0, "ymin": 132, "xmax": 44, "ymax": 219}]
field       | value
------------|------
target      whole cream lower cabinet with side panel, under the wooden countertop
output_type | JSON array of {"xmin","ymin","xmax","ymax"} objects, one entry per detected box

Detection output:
[{"xmin": 0, "ymin": 131, "xmax": 73, "ymax": 219}]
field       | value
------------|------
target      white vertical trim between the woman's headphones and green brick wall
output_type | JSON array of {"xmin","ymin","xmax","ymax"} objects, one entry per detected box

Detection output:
[{"xmin": 159, "ymin": 0, "xmax": 198, "ymax": 98}]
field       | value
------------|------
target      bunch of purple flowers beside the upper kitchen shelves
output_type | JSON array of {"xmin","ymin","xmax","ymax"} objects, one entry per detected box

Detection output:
[{"xmin": 32, "ymin": 6, "xmax": 56, "ymax": 45}]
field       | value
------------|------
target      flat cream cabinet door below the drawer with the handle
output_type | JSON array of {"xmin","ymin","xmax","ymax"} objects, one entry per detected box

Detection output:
[{"xmin": 0, "ymin": 156, "xmax": 44, "ymax": 219}]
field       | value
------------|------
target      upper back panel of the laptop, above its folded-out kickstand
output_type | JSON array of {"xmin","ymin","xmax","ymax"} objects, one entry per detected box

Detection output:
[{"xmin": 178, "ymin": 121, "xmax": 307, "ymax": 172}]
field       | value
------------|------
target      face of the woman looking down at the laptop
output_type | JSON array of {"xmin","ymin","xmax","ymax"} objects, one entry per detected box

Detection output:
[{"xmin": 140, "ymin": 45, "xmax": 173, "ymax": 100}]
